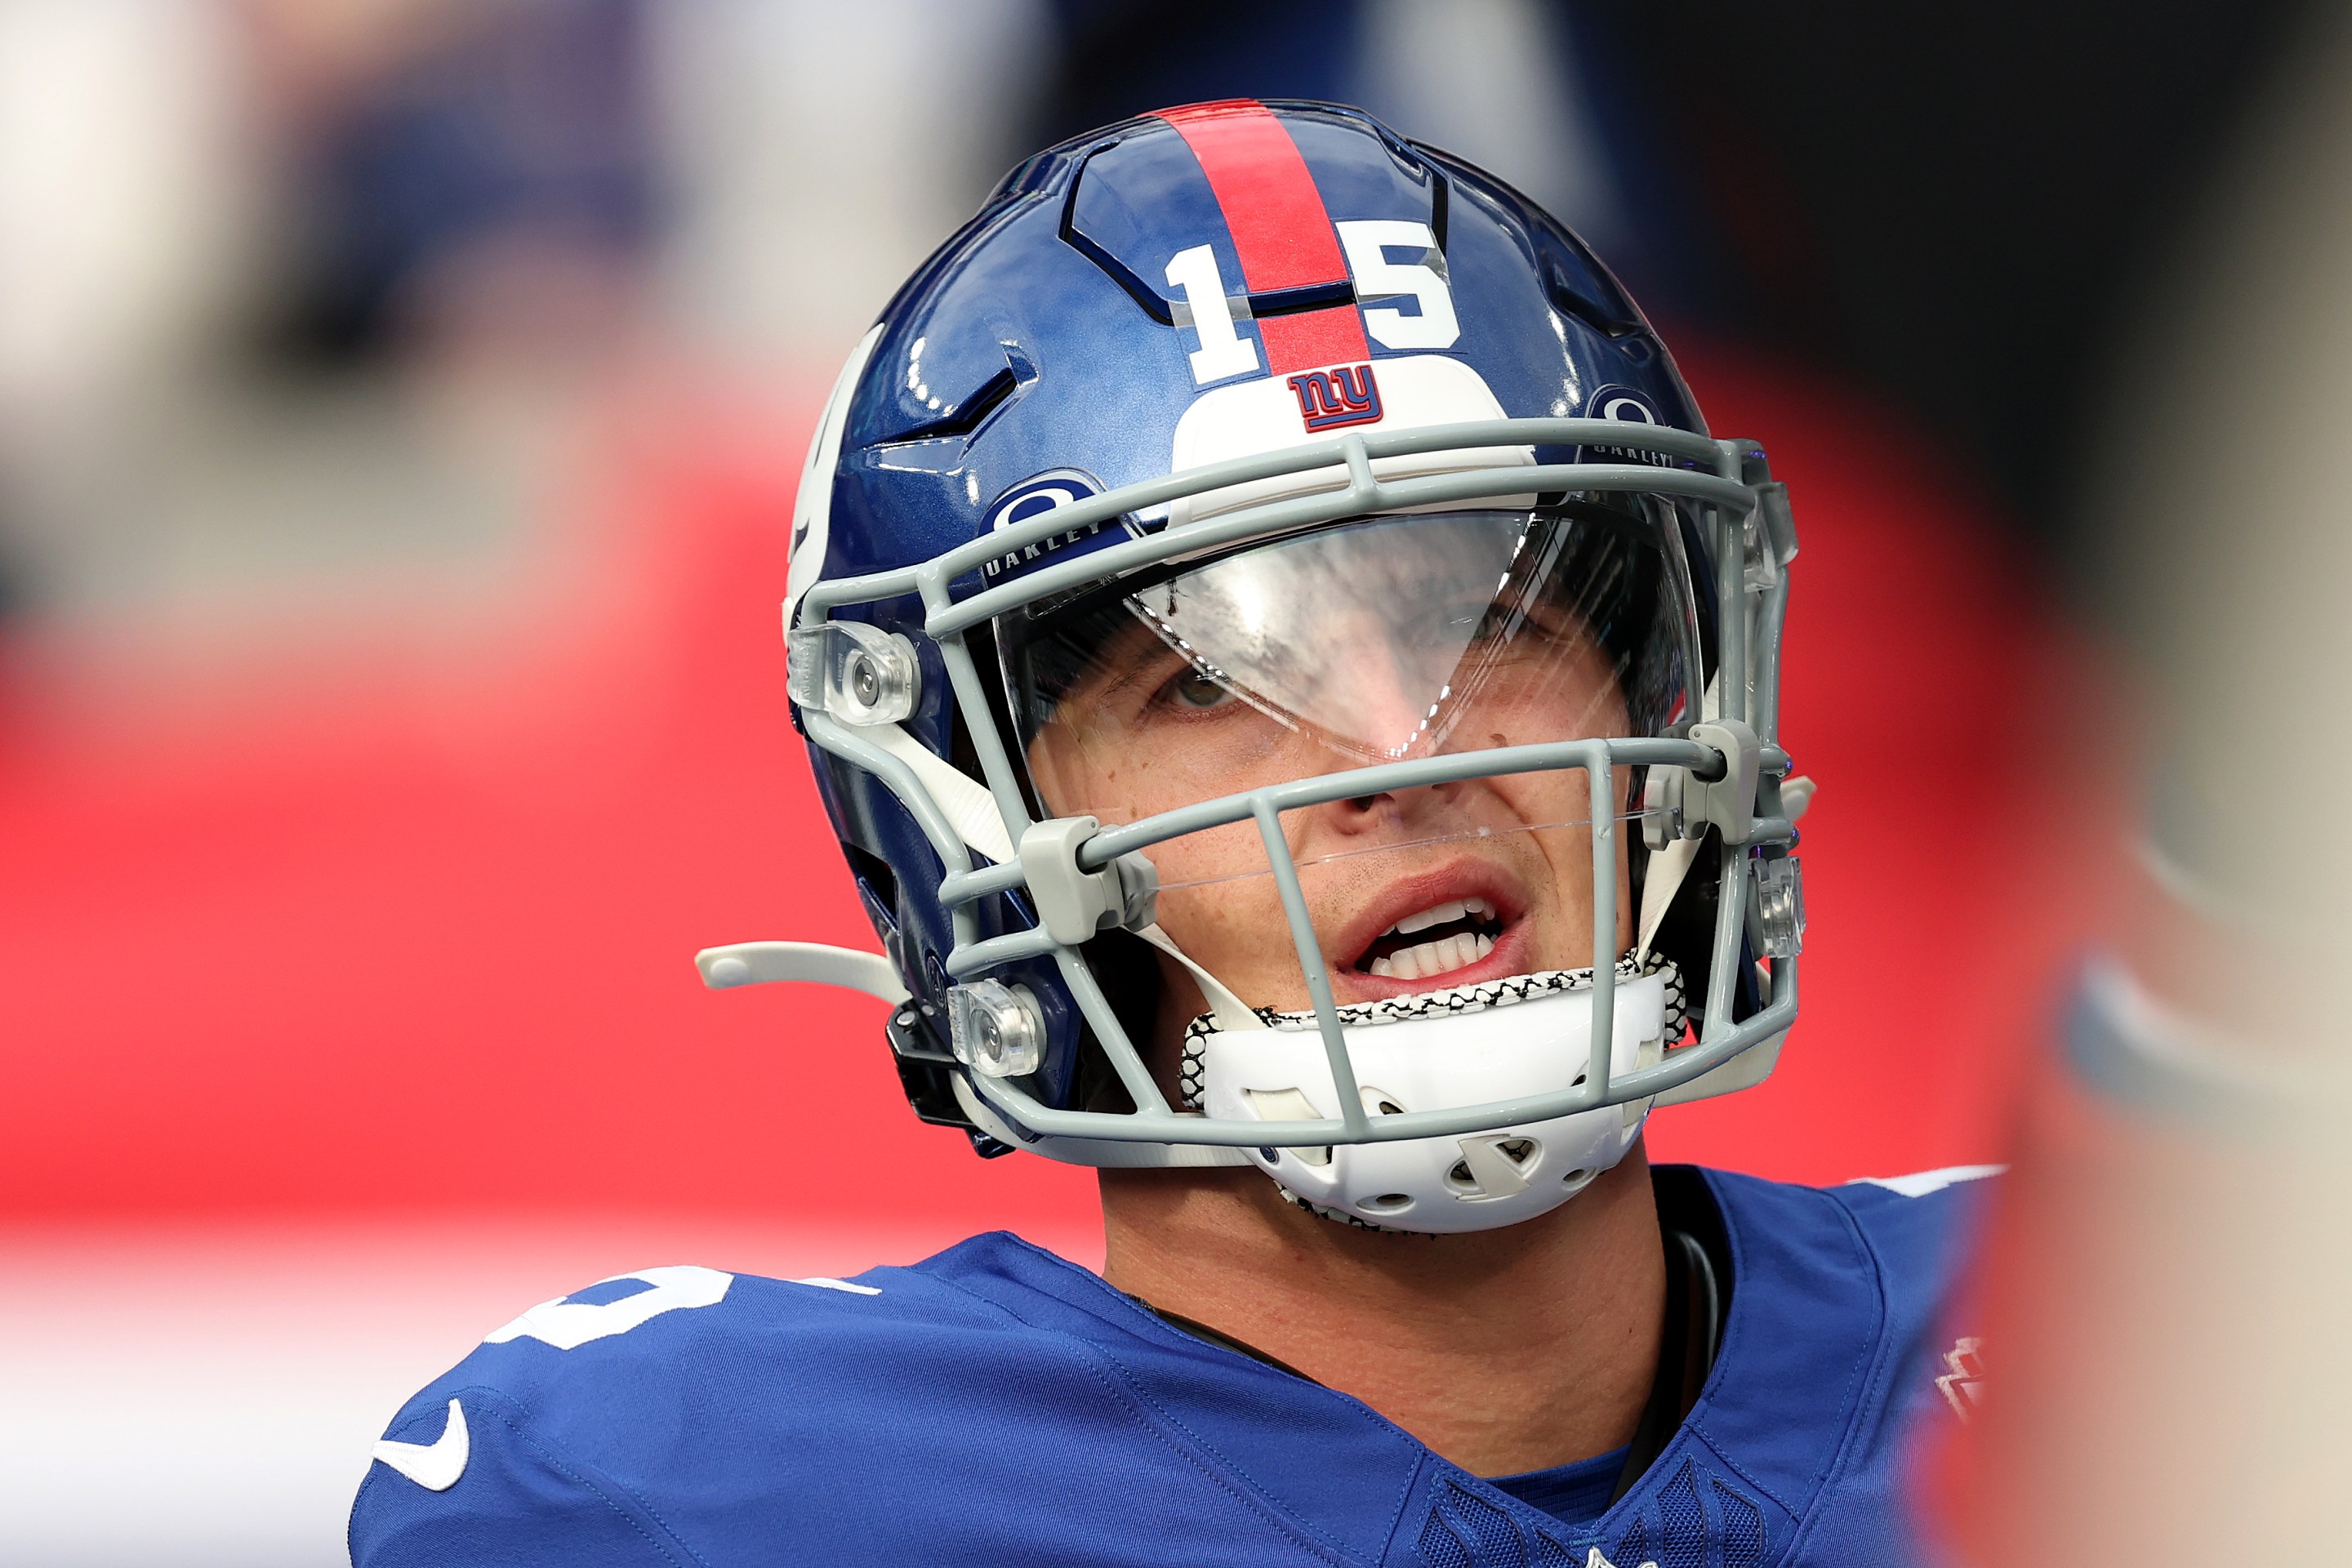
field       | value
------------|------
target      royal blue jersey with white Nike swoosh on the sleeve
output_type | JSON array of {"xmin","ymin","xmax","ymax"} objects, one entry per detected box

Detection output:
[{"xmin": 350, "ymin": 1171, "xmax": 1976, "ymax": 1568}]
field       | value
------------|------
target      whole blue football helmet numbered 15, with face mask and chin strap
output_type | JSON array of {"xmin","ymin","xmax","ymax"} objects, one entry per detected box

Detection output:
[{"xmin": 698, "ymin": 101, "xmax": 1809, "ymax": 1232}]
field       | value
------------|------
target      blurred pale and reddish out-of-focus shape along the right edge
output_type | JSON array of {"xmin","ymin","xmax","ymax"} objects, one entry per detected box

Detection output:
[{"xmin": 1943, "ymin": 10, "xmax": 2352, "ymax": 1568}]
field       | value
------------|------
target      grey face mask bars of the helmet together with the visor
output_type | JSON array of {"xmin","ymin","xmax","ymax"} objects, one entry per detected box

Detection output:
[{"xmin": 757, "ymin": 421, "xmax": 1794, "ymax": 1164}]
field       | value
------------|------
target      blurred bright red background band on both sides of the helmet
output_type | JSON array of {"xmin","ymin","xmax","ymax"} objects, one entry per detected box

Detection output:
[{"xmin": 0, "ymin": 358, "xmax": 2091, "ymax": 1232}]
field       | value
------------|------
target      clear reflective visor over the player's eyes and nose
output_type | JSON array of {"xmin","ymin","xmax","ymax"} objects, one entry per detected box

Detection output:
[{"xmin": 997, "ymin": 496, "xmax": 1698, "ymax": 891}]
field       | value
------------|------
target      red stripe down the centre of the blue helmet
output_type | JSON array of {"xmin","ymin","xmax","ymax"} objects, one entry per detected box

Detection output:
[{"xmin": 1157, "ymin": 99, "xmax": 1371, "ymax": 376}]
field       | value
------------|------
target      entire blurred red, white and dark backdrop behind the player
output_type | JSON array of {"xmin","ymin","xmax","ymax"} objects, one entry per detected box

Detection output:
[{"xmin": 0, "ymin": 0, "xmax": 2301, "ymax": 1568}]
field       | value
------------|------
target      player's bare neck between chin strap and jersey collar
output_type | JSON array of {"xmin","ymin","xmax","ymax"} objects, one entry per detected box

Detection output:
[{"xmin": 1103, "ymin": 1145, "xmax": 1665, "ymax": 1477}]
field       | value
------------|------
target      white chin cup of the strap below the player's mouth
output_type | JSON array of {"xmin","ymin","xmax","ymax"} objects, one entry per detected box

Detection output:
[{"xmin": 1195, "ymin": 964, "xmax": 1679, "ymax": 1234}]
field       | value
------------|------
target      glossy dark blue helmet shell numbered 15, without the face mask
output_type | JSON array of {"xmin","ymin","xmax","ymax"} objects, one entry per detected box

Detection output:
[{"xmin": 793, "ymin": 101, "xmax": 1713, "ymax": 1152}]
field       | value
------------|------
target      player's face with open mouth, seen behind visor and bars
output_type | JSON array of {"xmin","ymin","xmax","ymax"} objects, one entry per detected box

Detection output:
[{"xmin": 1030, "ymin": 514, "xmax": 1630, "ymax": 1032}]
